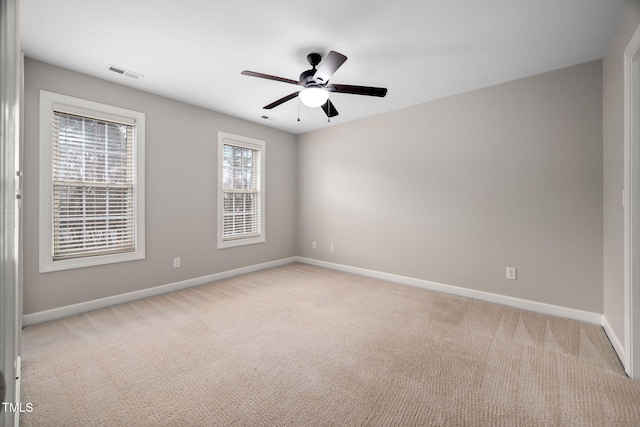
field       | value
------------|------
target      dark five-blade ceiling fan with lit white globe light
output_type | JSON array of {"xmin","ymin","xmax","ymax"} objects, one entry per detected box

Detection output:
[{"xmin": 241, "ymin": 51, "xmax": 387, "ymax": 120}]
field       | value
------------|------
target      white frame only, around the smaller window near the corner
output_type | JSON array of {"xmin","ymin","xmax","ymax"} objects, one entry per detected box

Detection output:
[{"xmin": 218, "ymin": 132, "xmax": 266, "ymax": 249}]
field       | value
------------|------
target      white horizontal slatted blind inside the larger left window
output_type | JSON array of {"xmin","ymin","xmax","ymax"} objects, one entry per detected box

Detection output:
[{"xmin": 52, "ymin": 110, "xmax": 135, "ymax": 260}]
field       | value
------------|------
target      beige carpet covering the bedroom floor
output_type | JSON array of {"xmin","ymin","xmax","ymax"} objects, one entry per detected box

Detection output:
[{"xmin": 21, "ymin": 264, "xmax": 640, "ymax": 426}]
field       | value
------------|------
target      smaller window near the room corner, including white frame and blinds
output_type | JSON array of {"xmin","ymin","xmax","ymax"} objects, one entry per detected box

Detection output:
[{"xmin": 218, "ymin": 132, "xmax": 265, "ymax": 249}]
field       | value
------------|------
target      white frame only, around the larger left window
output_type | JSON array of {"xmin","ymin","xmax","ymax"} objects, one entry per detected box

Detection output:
[{"xmin": 39, "ymin": 90, "xmax": 145, "ymax": 273}]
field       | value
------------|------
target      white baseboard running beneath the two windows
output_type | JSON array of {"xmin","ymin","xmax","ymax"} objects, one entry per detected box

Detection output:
[{"xmin": 22, "ymin": 257, "xmax": 296, "ymax": 327}]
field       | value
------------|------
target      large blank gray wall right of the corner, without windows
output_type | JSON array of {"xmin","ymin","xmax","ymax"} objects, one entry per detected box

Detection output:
[{"xmin": 297, "ymin": 61, "xmax": 603, "ymax": 313}]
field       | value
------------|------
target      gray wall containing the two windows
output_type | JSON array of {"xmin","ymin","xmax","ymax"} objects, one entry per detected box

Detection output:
[{"xmin": 24, "ymin": 59, "xmax": 296, "ymax": 314}]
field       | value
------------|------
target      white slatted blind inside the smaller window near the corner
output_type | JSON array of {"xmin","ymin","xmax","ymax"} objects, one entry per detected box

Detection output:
[{"xmin": 222, "ymin": 144, "xmax": 262, "ymax": 241}]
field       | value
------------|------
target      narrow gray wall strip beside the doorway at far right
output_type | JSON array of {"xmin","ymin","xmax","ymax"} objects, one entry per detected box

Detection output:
[{"xmin": 602, "ymin": 0, "xmax": 640, "ymax": 345}]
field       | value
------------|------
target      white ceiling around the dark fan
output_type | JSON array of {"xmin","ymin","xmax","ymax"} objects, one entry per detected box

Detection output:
[{"xmin": 21, "ymin": 0, "xmax": 626, "ymax": 134}]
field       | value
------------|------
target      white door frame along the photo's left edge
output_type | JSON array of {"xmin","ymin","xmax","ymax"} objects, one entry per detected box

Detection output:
[{"xmin": 0, "ymin": 0, "xmax": 24, "ymax": 427}]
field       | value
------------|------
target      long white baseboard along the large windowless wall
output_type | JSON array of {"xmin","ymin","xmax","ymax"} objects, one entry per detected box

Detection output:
[{"xmin": 296, "ymin": 257, "xmax": 603, "ymax": 326}]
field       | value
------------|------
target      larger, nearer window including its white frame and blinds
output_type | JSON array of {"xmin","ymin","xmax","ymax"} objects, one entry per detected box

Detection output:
[{"xmin": 40, "ymin": 91, "xmax": 145, "ymax": 272}]
